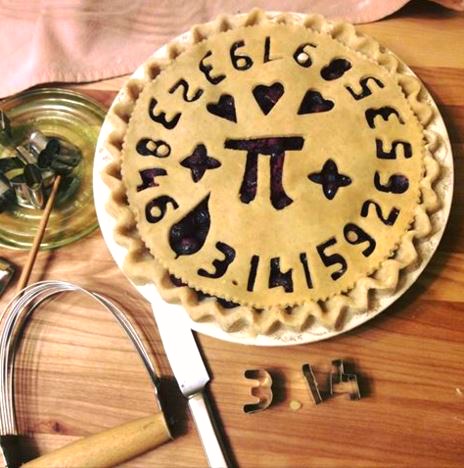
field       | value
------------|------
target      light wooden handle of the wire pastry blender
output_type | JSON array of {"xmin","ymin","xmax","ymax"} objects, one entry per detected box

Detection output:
[{"xmin": 22, "ymin": 413, "xmax": 172, "ymax": 468}]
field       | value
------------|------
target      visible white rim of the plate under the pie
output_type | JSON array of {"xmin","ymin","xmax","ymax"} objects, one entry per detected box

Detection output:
[{"xmin": 93, "ymin": 19, "xmax": 454, "ymax": 346}]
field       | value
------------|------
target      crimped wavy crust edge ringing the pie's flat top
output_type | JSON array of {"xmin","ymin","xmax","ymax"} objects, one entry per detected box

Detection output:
[{"xmin": 102, "ymin": 10, "xmax": 441, "ymax": 334}]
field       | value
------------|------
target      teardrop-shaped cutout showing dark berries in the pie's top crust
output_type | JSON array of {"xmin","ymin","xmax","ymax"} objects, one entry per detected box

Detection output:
[{"xmin": 169, "ymin": 194, "xmax": 211, "ymax": 257}]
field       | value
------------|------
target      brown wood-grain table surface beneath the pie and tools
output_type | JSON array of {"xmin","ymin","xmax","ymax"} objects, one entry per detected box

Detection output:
[{"xmin": 0, "ymin": 2, "xmax": 464, "ymax": 467}]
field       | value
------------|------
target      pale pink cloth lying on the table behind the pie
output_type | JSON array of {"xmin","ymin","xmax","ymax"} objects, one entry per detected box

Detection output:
[{"xmin": 0, "ymin": 0, "xmax": 464, "ymax": 97}]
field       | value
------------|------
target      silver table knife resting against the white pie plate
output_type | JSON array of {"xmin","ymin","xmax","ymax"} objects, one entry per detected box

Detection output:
[{"xmin": 152, "ymin": 304, "xmax": 231, "ymax": 468}]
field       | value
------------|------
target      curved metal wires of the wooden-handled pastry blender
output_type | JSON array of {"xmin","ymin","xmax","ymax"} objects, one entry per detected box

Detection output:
[{"xmin": 0, "ymin": 281, "xmax": 162, "ymax": 436}]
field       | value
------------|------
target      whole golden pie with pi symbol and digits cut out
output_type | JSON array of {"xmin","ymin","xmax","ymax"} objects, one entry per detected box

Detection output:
[{"xmin": 99, "ymin": 10, "xmax": 440, "ymax": 334}]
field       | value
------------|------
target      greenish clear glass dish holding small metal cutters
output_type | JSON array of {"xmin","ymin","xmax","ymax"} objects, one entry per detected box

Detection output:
[{"xmin": 0, "ymin": 88, "xmax": 106, "ymax": 250}]
